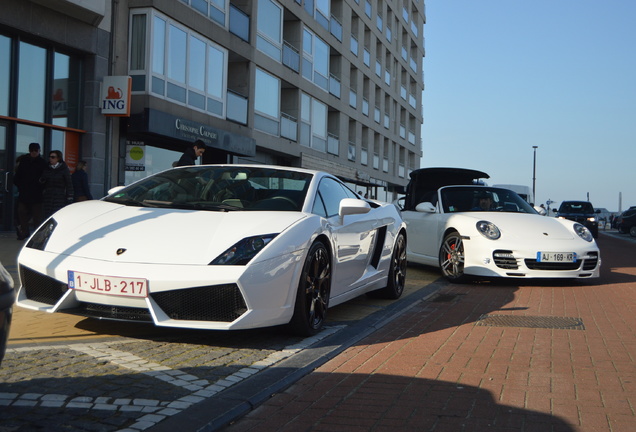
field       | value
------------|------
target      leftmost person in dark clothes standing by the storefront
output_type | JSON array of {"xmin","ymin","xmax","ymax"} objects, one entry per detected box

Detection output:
[{"xmin": 13, "ymin": 143, "xmax": 46, "ymax": 240}]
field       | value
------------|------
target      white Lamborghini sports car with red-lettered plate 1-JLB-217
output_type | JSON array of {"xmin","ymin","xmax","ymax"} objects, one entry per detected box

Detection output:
[{"xmin": 17, "ymin": 165, "xmax": 406, "ymax": 335}]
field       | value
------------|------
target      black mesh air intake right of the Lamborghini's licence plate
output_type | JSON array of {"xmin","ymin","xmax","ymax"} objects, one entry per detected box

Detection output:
[{"xmin": 150, "ymin": 284, "xmax": 247, "ymax": 322}]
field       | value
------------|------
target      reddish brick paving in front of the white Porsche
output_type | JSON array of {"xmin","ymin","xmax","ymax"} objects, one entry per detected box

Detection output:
[{"xmin": 227, "ymin": 236, "xmax": 636, "ymax": 432}]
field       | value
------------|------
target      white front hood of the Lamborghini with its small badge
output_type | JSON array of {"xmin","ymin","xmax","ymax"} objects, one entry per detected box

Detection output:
[{"xmin": 36, "ymin": 201, "xmax": 306, "ymax": 265}]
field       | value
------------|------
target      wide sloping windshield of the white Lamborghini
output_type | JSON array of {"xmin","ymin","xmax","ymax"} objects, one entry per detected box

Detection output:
[{"xmin": 104, "ymin": 165, "xmax": 312, "ymax": 211}]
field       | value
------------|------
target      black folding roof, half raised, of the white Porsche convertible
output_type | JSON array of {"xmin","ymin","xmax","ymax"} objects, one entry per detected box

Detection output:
[{"xmin": 404, "ymin": 167, "xmax": 490, "ymax": 210}]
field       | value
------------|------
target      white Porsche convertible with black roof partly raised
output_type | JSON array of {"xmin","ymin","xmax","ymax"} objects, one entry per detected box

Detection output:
[{"xmin": 402, "ymin": 168, "xmax": 601, "ymax": 282}]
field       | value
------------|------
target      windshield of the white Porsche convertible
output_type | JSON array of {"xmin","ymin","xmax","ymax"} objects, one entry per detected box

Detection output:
[{"xmin": 440, "ymin": 186, "xmax": 537, "ymax": 214}]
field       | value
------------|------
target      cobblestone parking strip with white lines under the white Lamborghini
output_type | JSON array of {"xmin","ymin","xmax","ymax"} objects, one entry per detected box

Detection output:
[{"xmin": 0, "ymin": 233, "xmax": 439, "ymax": 432}]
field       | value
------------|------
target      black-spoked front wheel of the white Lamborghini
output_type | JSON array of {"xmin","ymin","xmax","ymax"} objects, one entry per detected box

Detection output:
[{"xmin": 289, "ymin": 241, "xmax": 331, "ymax": 336}]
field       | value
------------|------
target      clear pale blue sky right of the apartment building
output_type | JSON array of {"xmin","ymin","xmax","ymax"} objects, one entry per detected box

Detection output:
[{"xmin": 421, "ymin": 0, "xmax": 636, "ymax": 212}]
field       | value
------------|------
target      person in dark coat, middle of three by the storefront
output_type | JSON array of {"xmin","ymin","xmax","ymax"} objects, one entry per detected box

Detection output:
[{"xmin": 40, "ymin": 150, "xmax": 73, "ymax": 219}]
